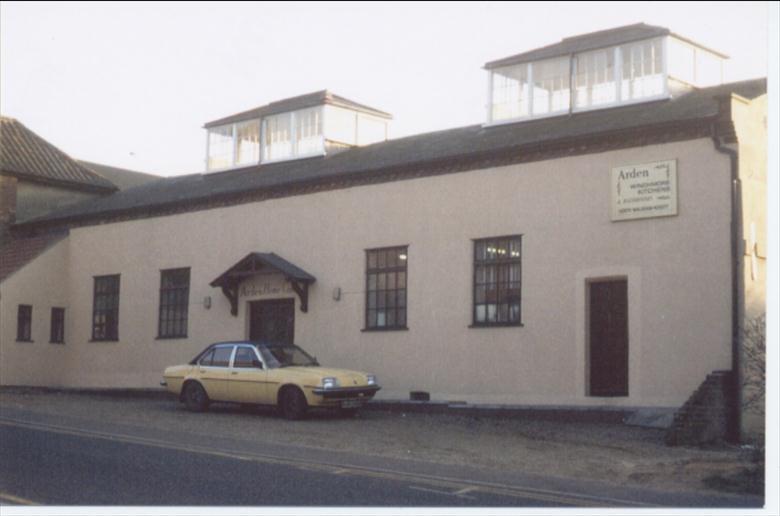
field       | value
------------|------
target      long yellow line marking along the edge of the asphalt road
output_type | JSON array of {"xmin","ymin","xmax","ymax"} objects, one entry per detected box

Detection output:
[{"xmin": 0, "ymin": 417, "xmax": 654, "ymax": 507}]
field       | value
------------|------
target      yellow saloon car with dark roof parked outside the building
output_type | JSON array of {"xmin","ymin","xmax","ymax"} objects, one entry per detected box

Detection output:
[{"xmin": 160, "ymin": 341, "xmax": 380, "ymax": 419}]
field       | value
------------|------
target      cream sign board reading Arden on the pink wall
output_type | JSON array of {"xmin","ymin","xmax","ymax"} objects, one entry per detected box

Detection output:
[{"xmin": 610, "ymin": 159, "xmax": 677, "ymax": 221}]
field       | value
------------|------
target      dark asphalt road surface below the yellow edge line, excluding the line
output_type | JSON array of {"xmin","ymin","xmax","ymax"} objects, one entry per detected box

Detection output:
[{"xmin": 0, "ymin": 425, "xmax": 567, "ymax": 507}]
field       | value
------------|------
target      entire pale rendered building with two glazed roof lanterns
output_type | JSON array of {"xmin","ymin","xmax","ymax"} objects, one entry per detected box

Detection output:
[{"xmin": 0, "ymin": 24, "xmax": 766, "ymax": 440}]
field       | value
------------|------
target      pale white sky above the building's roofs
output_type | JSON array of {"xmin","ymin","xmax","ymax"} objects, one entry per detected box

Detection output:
[{"xmin": 0, "ymin": 2, "xmax": 768, "ymax": 176}]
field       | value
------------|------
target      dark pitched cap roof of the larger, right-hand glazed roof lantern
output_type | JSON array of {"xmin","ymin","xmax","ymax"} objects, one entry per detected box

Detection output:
[{"xmin": 485, "ymin": 23, "xmax": 727, "ymax": 69}]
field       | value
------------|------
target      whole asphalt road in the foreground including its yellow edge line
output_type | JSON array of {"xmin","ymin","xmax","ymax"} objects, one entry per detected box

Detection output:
[{"xmin": 0, "ymin": 408, "xmax": 760, "ymax": 508}]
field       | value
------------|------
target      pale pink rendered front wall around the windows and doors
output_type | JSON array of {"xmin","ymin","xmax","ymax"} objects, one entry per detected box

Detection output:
[{"xmin": 0, "ymin": 139, "xmax": 731, "ymax": 406}]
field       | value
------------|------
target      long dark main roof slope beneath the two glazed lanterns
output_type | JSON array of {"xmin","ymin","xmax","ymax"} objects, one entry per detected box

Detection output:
[{"xmin": 17, "ymin": 79, "xmax": 766, "ymax": 230}]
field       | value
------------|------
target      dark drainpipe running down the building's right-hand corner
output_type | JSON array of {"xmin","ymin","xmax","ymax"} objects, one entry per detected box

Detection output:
[{"xmin": 712, "ymin": 118, "xmax": 742, "ymax": 443}]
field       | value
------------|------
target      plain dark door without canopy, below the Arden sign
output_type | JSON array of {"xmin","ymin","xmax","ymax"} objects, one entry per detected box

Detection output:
[{"xmin": 588, "ymin": 279, "xmax": 628, "ymax": 396}]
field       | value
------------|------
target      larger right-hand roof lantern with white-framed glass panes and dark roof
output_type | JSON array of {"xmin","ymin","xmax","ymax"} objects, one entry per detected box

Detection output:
[{"xmin": 485, "ymin": 23, "xmax": 728, "ymax": 125}]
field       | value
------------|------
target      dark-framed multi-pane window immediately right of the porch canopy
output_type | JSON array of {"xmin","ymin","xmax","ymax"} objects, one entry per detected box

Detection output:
[{"xmin": 366, "ymin": 246, "xmax": 409, "ymax": 330}]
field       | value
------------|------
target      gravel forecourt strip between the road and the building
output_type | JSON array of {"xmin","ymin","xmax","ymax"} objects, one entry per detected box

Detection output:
[{"xmin": 0, "ymin": 389, "xmax": 752, "ymax": 492}]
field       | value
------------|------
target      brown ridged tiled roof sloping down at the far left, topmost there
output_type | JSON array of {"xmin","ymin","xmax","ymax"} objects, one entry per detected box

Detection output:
[{"xmin": 0, "ymin": 116, "xmax": 116, "ymax": 192}]
